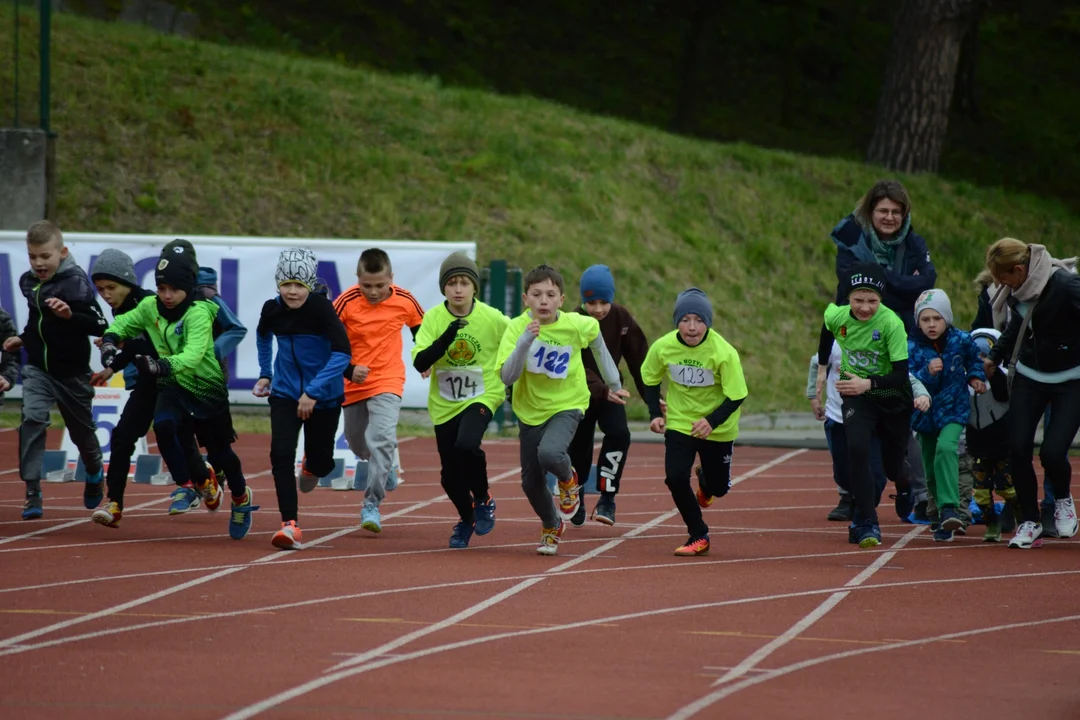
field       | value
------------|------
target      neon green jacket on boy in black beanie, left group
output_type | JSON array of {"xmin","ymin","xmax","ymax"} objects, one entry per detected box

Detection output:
[{"xmin": 104, "ymin": 295, "xmax": 229, "ymax": 403}]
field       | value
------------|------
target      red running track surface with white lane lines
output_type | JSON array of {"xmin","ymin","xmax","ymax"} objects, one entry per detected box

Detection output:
[{"xmin": 0, "ymin": 432, "xmax": 1080, "ymax": 720}]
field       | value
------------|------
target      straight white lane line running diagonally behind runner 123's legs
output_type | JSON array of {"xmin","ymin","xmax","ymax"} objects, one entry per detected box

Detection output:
[{"xmin": 230, "ymin": 449, "xmax": 806, "ymax": 720}]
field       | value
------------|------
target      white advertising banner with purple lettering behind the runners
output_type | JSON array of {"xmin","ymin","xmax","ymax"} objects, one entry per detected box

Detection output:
[{"xmin": 0, "ymin": 232, "xmax": 476, "ymax": 408}]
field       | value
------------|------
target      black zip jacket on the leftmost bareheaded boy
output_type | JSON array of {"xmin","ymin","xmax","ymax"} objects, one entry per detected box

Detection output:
[{"xmin": 18, "ymin": 255, "xmax": 109, "ymax": 378}]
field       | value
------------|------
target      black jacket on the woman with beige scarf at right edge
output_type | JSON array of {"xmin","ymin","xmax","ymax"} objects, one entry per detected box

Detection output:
[{"xmin": 990, "ymin": 270, "xmax": 1080, "ymax": 372}]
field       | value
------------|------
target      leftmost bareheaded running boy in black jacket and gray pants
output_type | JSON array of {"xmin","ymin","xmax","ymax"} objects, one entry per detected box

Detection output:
[{"xmin": 3, "ymin": 220, "xmax": 107, "ymax": 520}]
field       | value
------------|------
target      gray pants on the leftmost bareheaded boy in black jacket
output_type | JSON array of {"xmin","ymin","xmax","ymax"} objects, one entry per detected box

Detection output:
[{"xmin": 18, "ymin": 365, "xmax": 102, "ymax": 484}]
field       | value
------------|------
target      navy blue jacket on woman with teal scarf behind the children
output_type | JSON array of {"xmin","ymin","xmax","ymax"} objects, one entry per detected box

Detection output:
[{"xmin": 832, "ymin": 215, "xmax": 937, "ymax": 335}]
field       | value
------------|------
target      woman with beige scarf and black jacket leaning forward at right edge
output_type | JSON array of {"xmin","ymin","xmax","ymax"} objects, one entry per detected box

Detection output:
[{"xmin": 984, "ymin": 237, "xmax": 1080, "ymax": 549}]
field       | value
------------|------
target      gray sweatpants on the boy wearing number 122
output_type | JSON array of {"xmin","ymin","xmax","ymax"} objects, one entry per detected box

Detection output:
[{"xmin": 517, "ymin": 410, "xmax": 582, "ymax": 528}]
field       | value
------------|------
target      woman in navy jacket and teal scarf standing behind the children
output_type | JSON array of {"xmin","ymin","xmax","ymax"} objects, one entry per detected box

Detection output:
[{"xmin": 818, "ymin": 180, "xmax": 937, "ymax": 522}]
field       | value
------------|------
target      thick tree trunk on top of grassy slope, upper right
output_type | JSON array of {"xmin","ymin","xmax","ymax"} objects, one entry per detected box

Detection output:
[{"xmin": 866, "ymin": 0, "xmax": 980, "ymax": 173}]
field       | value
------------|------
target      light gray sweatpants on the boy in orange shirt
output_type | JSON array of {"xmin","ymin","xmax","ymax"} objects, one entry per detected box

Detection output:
[{"xmin": 341, "ymin": 393, "xmax": 402, "ymax": 507}]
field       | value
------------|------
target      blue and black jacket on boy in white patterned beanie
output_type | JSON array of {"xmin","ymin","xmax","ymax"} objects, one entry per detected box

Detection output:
[{"xmin": 255, "ymin": 293, "xmax": 352, "ymax": 408}]
